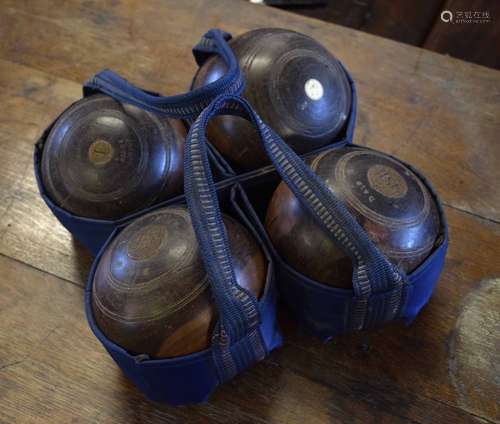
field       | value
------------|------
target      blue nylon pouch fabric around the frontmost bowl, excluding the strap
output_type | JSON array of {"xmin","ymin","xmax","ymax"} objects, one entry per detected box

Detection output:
[{"xmin": 85, "ymin": 186, "xmax": 282, "ymax": 405}]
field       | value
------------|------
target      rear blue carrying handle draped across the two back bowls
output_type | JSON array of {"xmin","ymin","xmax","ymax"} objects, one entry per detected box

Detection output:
[{"xmin": 83, "ymin": 29, "xmax": 244, "ymax": 121}]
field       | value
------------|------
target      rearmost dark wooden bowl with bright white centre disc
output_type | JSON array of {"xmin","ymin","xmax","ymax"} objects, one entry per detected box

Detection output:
[{"xmin": 193, "ymin": 28, "xmax": 351, "ymax": 170}]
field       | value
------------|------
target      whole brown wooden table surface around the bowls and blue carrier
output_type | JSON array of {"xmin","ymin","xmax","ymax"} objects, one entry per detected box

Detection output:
[{"xmin": 0, "ymin": 0, "xmax": 500, "ymax": 424}]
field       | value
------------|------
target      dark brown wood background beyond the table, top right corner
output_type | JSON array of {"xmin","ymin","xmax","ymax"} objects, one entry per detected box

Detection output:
[{"xmin": 268, "ymin": 0, "xmax": 500, "ymax": 69}]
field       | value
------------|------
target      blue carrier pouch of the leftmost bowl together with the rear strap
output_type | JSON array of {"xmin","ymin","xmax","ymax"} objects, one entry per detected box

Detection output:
[{"xmin": 34, "ymin": 30, "xmax": 244, "ymax": 255}]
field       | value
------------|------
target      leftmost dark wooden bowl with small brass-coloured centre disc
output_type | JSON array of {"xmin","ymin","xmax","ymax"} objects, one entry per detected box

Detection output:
[{"xmin": 40, "ymin": 95, "xmax": 186, "ymax": 219}]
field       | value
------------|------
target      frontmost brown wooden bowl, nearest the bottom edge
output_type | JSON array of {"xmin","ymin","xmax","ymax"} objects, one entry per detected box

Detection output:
[{"xmin": 92, "ymin": 206, "xmax": 267, "ymax": 358}]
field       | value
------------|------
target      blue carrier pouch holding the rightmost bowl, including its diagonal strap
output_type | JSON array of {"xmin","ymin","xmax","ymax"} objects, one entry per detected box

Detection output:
[{"xmin": 188, "ymin": 95, "xmax": 448, "ymax": 341}]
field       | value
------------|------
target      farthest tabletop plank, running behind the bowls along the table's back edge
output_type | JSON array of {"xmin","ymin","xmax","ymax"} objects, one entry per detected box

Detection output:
[{"xmin": 0, "ymin": 0, "xmax": 500, "ymax": 221}]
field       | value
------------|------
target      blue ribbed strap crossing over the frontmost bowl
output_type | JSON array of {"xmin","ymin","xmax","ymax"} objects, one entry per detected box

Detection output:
[{"xmin": 184, "ymin": 101, "xmax": 266, "ymax": 382}]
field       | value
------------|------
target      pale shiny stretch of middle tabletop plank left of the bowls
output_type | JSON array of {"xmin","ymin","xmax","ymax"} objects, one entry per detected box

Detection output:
[{"xmin": 0, "ymin": 60, "xmax": 91, "ymax": 284}]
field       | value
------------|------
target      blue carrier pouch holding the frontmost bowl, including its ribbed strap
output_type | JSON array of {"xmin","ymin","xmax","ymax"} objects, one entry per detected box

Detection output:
[{"xmin": 85, "ymin": 112, "xmax": 282, "ymax": 405}]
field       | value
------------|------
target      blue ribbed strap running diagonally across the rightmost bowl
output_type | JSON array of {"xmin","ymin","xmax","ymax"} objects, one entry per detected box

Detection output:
[{"xmin": 193, "ymin": 95, "xmax": 406, "ymax": 330}]
